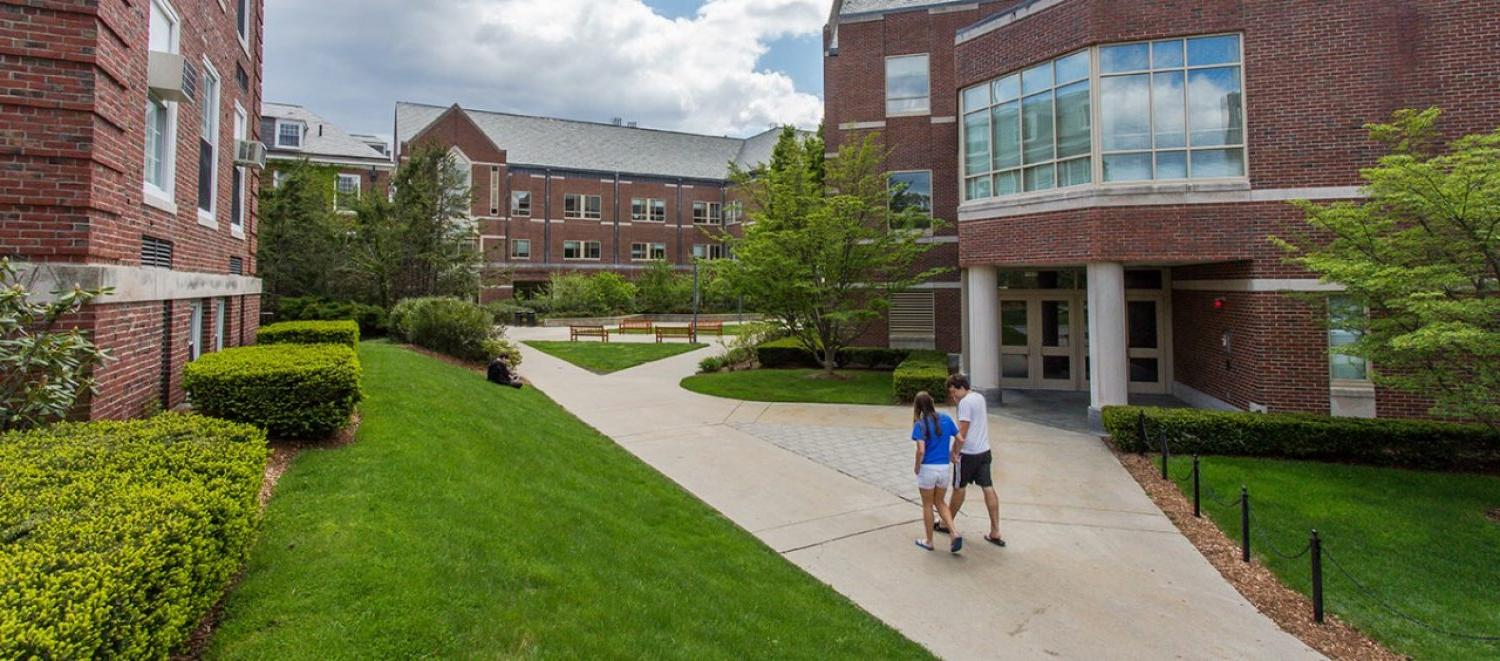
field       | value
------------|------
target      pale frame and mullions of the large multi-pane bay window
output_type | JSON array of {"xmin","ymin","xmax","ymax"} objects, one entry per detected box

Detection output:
[{"xmin": 957, "ymin": 31, "xmax": 1253, "ymax": 203}]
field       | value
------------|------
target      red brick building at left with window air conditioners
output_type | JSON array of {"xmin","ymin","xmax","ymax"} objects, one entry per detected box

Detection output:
[{"xmin": 0, "ymin": 0, "xmax": 264, "ymax": 418}]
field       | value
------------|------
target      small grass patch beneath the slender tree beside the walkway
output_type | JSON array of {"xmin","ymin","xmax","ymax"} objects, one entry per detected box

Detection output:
[{"xmin": 683, "ymin": 369, "xmax": 896, "ymax": 405}]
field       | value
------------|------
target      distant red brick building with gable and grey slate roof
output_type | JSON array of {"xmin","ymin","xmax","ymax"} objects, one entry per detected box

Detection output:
[{"xmin": 395, "ymin": 103, "xmax": 779, "ymax": 301}]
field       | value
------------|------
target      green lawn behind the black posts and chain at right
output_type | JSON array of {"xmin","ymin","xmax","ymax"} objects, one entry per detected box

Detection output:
[{"xmin": 1172, "ymin": 457, "xmax": 1500, "ymax": 658}]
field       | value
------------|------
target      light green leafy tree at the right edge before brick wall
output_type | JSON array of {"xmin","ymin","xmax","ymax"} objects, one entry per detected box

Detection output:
[{"xmin": 1272, "ymin": 108, "xmax": 1500, "ymax": 430}]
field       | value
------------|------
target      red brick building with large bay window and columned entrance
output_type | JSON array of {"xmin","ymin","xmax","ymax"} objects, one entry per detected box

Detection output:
[{"xmin": 825, "ymin": 0, "xmax": 1500, "ymax": 417}]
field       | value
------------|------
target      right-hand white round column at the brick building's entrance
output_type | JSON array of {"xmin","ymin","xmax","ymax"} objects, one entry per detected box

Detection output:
[{"xmin": 1089, "ymin": 262, "xmax": 1130, "ymax": 427}]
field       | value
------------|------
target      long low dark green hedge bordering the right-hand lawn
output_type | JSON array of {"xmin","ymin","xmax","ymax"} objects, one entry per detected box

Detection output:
[{"xmin": 1104, "ymin": 406, "xmax": 1500, "ymax": 471}]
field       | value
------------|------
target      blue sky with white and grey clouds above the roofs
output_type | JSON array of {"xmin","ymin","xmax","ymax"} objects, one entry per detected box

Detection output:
[{"xmin": 266, "ymin": 0, "xmax": 831, "ymax": 136}]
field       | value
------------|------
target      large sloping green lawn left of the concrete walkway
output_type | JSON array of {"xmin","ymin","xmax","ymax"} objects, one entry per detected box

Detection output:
[{"xmin": 210, "ymin": 342, "xmax": 929, "ymax": 661}]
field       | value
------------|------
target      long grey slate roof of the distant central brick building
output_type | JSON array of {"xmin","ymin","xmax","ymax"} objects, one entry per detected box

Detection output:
[{"xmin": 396, "ymin": 102, "xmax": 798, "ymax": 180}]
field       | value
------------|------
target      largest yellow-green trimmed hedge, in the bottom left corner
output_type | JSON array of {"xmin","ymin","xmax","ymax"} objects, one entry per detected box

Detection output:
[{"xmin": 0, "ymin": 414, "xmax": 267, "ymax": 658}]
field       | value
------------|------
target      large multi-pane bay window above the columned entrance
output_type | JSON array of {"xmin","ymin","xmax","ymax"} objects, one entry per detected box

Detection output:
[{"xmin": 960, "ymin": 34, "xmax": 1247, "ymax": 201}]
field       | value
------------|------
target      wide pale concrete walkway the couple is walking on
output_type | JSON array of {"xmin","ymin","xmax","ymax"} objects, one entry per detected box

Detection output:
[{"xmin": 512, "ymin": 328, "xmax": 1317, "ymax": 660}]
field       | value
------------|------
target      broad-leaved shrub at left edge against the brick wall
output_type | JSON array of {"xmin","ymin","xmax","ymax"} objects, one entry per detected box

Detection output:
[{"xmin": 0, "ymin": 259, "xmax": 111, "ymax": 432}]
